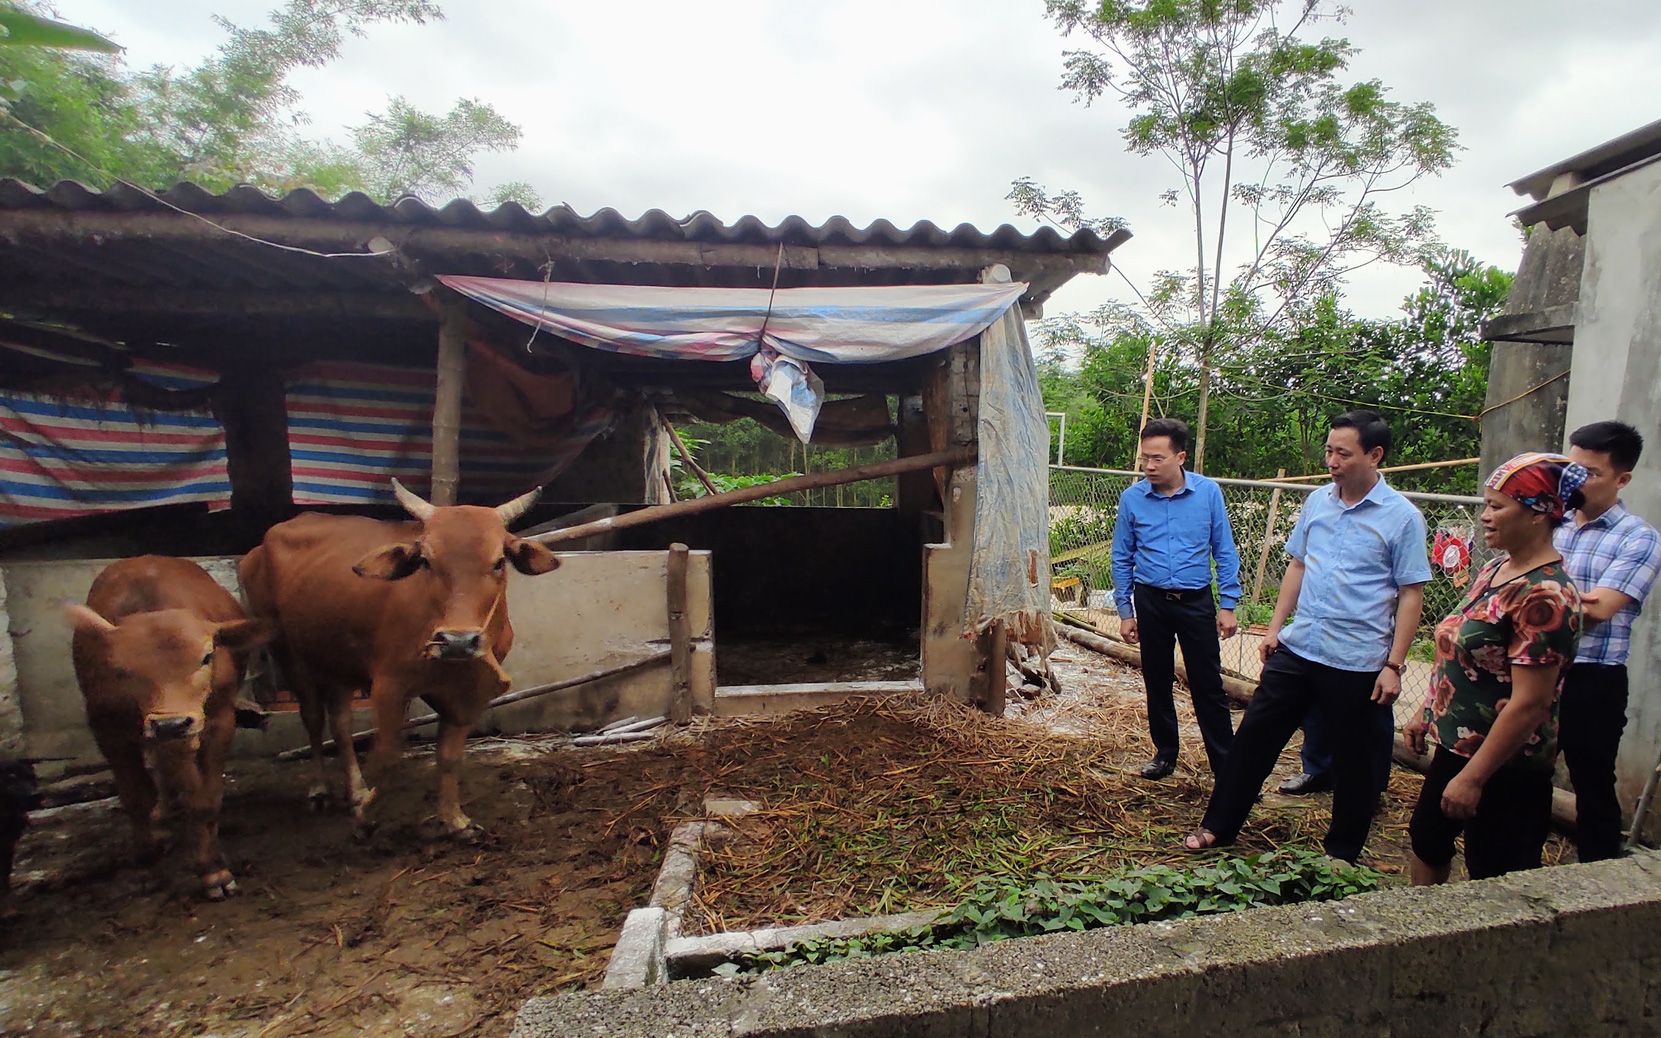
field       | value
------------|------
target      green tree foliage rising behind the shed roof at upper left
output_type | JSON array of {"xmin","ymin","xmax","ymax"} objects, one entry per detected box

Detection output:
[{"xmin": 0, "ymin": 0, "xmax": 535, "ymax": 201}]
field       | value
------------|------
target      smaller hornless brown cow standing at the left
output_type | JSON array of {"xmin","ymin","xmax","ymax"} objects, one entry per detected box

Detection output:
[{"xmin": 65, "ymin": 555, "xmax": 274, "ymax": 900}]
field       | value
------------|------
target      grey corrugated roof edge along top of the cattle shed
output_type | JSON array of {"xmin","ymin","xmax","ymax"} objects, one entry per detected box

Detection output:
[{"xmin": 0, "ymin": 178, "xmax": 1129, "ymax": 256}]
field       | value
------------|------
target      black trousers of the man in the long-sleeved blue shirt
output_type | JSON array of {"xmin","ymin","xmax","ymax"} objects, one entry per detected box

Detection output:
[{"xmin": 1133, "ymin": 585, "xmax": 1234, "ymax": 774}]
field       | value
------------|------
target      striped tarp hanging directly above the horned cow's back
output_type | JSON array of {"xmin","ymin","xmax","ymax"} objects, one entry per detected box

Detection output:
[{"xmin": 287, "ymin": 362, "xmax": 586, "ymax": 505}]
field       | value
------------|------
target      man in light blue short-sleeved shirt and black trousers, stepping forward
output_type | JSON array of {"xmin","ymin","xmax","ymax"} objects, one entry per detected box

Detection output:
[{"xmin": 1183, "ymin": 410, "xmax": 1430, "ymax": 862}]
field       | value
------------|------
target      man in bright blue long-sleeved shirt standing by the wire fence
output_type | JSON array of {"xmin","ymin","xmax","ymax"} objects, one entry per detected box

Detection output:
[{"xmin": 1113, "ymin": 419, "xmax": 1241, "ymax": 779}]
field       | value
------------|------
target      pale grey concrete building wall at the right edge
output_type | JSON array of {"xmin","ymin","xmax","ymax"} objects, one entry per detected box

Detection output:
[{"xmin": 1566, "ymin": 163, "xmax": 1661, "ymax": 832}]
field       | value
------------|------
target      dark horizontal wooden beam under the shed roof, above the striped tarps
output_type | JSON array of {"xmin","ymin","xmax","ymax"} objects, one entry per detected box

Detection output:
[{"xmin": 0, "ymin": 282, "xmax": 435, "ymax": 321}]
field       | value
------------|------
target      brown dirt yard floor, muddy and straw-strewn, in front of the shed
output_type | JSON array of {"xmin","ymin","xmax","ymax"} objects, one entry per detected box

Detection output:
[{"xmin": 0, "ymin": 646, "xmax": 1561, "ymax": 1038}]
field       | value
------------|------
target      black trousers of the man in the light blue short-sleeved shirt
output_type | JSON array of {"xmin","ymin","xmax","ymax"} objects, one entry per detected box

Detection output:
[{"xmin": 1201, "ymin": 648, "xmax": 1379, "ymax": 862}]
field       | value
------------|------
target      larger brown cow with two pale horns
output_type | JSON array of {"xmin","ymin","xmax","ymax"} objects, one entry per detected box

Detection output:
[{"xmin": 243, "ymin": 480, "xmax": 560, "ymax": 832}]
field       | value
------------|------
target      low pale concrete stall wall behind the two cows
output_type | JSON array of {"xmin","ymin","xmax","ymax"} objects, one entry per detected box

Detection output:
[{"xmin": 0, "ymin": 551, "xmax": 714, "ymax": 762}]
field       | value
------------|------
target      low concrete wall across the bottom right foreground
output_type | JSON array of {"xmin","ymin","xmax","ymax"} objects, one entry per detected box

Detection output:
[{"xmin": 513, "ymin": 854, "xmax": 1661, "ymax": 1038}]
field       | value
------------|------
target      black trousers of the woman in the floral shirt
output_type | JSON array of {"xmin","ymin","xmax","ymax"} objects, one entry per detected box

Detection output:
[{"xmin": 1407, "ymin": 746, "xmax": 1551, "ymax": 880}]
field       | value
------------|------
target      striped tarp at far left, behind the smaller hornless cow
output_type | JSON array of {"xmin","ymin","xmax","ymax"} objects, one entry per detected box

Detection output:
[{"xmin": 0, "ymin": 362, "xmax": 231, "ymax": 525}]
